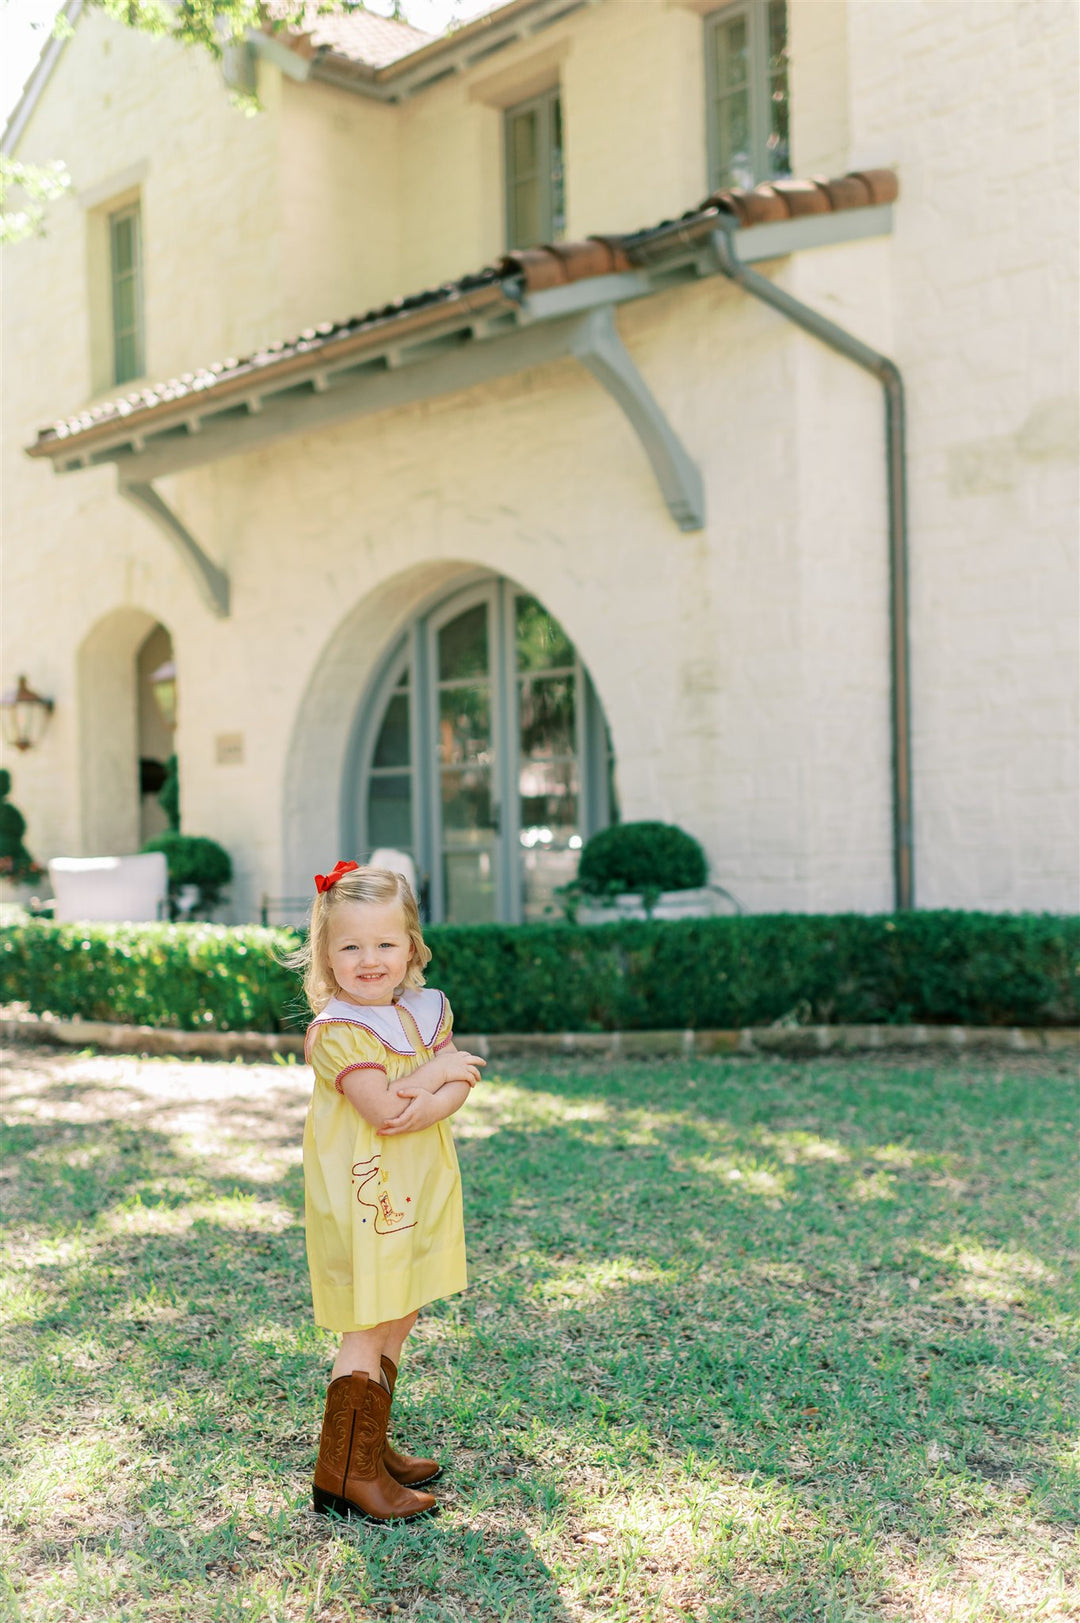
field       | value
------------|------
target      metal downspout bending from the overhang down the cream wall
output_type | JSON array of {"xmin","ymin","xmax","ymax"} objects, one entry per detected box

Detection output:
[{"xmin": 713, "ymin": 221, "xmax": 914, "ymax": 912}]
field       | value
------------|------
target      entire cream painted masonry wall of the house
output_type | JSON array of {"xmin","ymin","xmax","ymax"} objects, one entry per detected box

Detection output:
[{"xmin": 3, "ymin": 0, "xmax": 1078, "ymax": 917}]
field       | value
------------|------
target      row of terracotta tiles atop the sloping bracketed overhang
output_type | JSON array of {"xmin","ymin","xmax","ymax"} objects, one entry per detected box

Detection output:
[{"xmin": 32, "ymin": 166, "xmax": 900, "ymax": 454}]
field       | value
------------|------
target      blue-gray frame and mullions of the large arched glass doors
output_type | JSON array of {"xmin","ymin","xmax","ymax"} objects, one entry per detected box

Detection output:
[{"xmin": 341, "ymin": 576, "xmax": 617, "ymax": 923}]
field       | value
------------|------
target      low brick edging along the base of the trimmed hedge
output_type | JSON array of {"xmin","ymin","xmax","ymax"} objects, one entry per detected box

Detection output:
[{"xmin": 0, "ymin": 1014, "xmax": 1080, "ymax": 1060}]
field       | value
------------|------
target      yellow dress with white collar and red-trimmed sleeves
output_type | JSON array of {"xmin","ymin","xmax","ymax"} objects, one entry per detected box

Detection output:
[{"xmin": 304, "ymin": 988, "xmax": 468, "ymax": 1334}]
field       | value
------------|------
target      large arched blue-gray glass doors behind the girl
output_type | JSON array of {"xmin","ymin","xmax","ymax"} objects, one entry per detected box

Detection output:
[{"xmin": 346, "ymin": 579, "xmax": 614, "ymax": 923}]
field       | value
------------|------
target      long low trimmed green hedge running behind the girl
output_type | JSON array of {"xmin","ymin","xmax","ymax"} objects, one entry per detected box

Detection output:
[{"xmin": 0, "ymin": 912, "xmax": 1080, "ymax": 1032}]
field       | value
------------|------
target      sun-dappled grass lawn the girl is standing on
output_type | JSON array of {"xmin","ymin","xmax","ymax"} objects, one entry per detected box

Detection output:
[{"xmin": 0, "ymin": 1050, "xmax": 1080, "ymax": 1623}]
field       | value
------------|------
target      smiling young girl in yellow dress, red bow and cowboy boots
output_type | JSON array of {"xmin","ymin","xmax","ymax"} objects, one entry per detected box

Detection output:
[{"xmin": 296, "ymin": 862, "xmax": 484, "ymax": 1521}]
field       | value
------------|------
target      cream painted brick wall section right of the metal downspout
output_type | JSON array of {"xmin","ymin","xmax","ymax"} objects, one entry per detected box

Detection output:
[{"xmin": 849, "ymin": 0, "xmax": 1080, "ymax": 907}]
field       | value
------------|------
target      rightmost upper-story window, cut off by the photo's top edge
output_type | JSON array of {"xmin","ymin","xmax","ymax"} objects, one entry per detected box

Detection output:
[{"xmin": 705, "ymin": 0, "xmax": 791, "ymax": 190}]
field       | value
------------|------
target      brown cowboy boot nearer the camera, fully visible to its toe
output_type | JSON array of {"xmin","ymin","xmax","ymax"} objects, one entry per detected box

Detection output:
[{"xmin": 312, "ymin": 1370, "xmax": 437, "ymax": 1522}]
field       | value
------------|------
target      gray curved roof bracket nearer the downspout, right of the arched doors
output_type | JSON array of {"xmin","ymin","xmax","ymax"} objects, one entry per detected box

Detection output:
[{"xmin": 570, "ymin": 305, "xmax": 705, "ymax": 531}]
